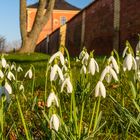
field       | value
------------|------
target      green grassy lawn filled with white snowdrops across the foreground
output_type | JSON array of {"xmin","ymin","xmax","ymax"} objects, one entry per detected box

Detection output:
[{"xmin": 0, "ymin": 50, "xmax": 140, "ymax": 140}]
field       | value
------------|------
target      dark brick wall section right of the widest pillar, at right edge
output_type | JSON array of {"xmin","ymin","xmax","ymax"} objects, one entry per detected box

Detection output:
[{"xmin": 119, "ymin": 0, "xmax": 140, "ymax": 52}]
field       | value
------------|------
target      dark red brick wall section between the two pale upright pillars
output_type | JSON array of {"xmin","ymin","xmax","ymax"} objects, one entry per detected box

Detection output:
[{"xmin": 85, "ymin": 0, "xmax": 114, "ymax": 55}]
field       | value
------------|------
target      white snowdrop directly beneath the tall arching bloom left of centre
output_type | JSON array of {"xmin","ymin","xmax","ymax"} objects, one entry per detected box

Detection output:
[{"xmin": 50, "ymin": 64, "xmax": 64, "ymax": 81}]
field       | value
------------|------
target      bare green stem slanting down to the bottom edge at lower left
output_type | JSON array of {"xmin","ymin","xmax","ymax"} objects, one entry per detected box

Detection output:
[{"xmin": 16, "ymin": 96, "xmax": 30, "ymax": 140}]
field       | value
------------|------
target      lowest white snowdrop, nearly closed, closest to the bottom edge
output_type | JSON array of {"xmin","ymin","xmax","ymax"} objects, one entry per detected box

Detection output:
[{"xmin": 50, "ymin": 114, "xmax": 60, "ymax": 131}]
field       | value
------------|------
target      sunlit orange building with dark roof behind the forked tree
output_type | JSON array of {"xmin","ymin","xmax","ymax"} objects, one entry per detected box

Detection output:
[{"xmin": 27, "ymin": 0, "xmax": 80, "ymax": 44}]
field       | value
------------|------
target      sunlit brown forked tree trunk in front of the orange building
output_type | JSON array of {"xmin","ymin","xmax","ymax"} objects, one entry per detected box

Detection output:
[{"xmin": 19, "ymin": 0, "xmax": 55, "ymax": 53}]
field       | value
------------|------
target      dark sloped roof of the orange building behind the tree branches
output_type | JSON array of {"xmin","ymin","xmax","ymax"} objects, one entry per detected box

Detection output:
[{"xmin": 28, "ymin": 0, "xmax": 80, "ymax": 10}]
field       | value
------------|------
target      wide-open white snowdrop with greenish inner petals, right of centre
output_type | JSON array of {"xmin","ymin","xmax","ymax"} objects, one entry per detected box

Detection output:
[{"xmin": 100, "ymin": 65, "xmax": 118, "ymax": 83}]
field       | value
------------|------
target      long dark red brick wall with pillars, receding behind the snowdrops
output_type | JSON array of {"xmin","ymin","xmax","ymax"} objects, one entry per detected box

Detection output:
[{"xmin": 36, "ymin": 0, "xmax": 140, "ymax": 56}]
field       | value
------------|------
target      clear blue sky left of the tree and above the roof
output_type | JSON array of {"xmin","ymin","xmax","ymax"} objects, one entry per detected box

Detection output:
[{"xmin": 0, "ymin": 0, "xmax": 92, "ymax": 42}]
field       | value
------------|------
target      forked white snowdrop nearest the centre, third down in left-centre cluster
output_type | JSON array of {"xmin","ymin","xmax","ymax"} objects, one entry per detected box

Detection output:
[{"xmin": 61, "ymin": 77, "xmax": 73, "ymax": 93}]
